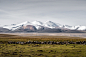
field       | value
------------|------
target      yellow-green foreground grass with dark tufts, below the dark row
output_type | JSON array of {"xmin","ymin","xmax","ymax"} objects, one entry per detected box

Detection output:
[{"xmin": 0, "ymin": 44, "xmax": 86, "ymax": 57}]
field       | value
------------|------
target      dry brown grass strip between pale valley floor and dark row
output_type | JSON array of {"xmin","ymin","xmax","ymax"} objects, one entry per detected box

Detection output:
[{"xmin": 0, "ymin": 34, "xmax": 86, "ymax": 42}]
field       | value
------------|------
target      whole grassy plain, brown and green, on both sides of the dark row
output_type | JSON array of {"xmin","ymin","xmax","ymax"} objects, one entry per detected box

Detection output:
[{"xmin": 0, "ymin": 34, "xmax": 86, "ymax": 57}]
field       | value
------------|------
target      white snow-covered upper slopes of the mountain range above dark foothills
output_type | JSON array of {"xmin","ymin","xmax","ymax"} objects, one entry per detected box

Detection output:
[{"xmin": 0, "ymin": 21, "xmax": 86, "ymax": 31}]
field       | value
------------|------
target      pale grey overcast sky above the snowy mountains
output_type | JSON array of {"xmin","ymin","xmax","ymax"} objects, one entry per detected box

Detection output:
[{"xmin": 0, "ymin": 0, "xmax": 86, "ymax": 26}]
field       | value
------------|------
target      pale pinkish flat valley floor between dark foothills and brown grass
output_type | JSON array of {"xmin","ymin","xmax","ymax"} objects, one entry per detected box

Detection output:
[{"xmin": 1, "ymin": 33, "xmax": 86, "ymax": 38}]
